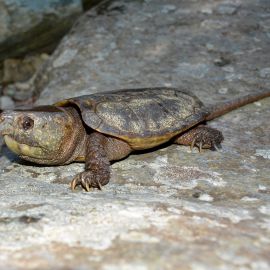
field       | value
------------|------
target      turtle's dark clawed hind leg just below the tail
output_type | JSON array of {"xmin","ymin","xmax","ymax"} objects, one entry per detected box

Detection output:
[{"xmin": 175, "ymin": 126, "xmax": 224, "ymax": 152}]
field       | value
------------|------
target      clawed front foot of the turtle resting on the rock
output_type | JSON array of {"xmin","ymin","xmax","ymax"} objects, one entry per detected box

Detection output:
[{"xmin": 70, "ymin": 171, "xmax": 109, "ymax": 191}]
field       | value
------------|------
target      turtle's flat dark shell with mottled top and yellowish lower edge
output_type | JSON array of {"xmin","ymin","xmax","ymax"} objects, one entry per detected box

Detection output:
[{"xmin": 54, "ymin": 88, "xmax": 206, "ymax": 149}]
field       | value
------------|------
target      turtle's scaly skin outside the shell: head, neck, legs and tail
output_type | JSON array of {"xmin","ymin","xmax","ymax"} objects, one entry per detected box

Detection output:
[{"xmin": 0, "ymin": 87, "xmax": 270, "ymax": 191}]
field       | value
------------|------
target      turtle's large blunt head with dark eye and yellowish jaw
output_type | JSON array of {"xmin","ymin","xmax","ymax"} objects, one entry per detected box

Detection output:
[{"xmin": 0, "ymin": 106, "xmax": 78, "ymax": 165}]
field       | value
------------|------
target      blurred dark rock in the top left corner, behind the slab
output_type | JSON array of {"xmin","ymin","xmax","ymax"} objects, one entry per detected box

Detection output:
[{"xmin": 0, "ymin": 0, "xmax": 82, "ymax": 62}]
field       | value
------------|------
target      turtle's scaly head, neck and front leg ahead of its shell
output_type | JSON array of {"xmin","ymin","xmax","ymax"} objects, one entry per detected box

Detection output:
[{"xmin": 0, "ymin": 107, "xmax": 132, "ymax": 191}]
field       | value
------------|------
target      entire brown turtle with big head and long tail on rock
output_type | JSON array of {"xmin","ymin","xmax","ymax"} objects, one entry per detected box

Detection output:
[{"xmin": 0, "ymin": 87, "xmax": 270, "ymax": 191}]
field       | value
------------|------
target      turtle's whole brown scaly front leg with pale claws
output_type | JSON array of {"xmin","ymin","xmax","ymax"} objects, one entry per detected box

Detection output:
[{"xmin": 71, "ymin": 132, "xmax": 110, "ymax": 191}]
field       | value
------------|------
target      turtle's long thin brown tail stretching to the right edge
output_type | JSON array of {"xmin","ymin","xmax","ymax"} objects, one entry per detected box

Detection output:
[{"xmin": 206, "ymin": 90, "xmax": 270, "ymax": 120}]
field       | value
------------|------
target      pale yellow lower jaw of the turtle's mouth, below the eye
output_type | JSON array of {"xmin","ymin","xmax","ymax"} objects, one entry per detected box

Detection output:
[{"xmin": 4, "ymin": 135, "xmax": 44, "ymax": 158}]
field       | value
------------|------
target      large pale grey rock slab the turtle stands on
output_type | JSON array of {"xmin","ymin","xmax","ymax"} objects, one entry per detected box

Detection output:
[{"xmin": 0, "ymin": 0, "xmax": 270, "ymax": 270}]
